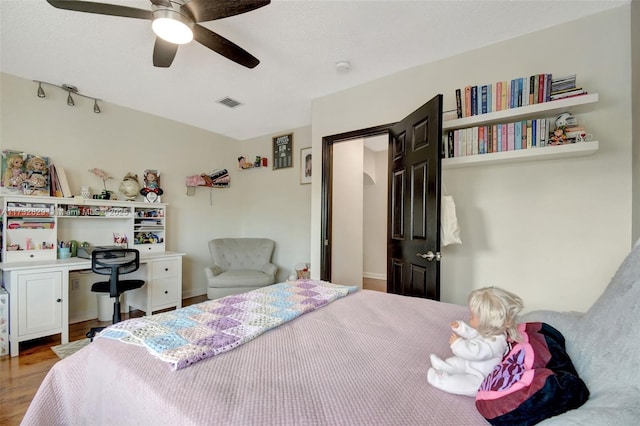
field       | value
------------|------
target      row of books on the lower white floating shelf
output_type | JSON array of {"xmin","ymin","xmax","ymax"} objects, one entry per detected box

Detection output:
[{"xmin": 444, "ymin": 118, "xmax": 550, "ymax": 158}]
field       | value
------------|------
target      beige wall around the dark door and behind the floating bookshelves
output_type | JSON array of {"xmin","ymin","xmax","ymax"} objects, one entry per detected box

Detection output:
[{"xmin": 310, "ymin": 6, "xmax": 632, "ymax": 311}]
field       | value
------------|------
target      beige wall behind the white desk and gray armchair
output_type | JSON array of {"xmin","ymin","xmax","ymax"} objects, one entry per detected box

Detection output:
[{"xmin": 0, "ymin": 74, "xmax": 311, "ymax": 297}]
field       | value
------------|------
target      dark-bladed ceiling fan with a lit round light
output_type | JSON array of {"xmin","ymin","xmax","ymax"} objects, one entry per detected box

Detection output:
[{"xmin": 47, "ymin": 0, "xmax": 271, "ymax": 68}]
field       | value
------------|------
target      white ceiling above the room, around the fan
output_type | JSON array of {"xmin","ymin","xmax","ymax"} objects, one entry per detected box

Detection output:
[{"xmin": 0, "ymin": 0, "xmax": 630, "ymax": 140}]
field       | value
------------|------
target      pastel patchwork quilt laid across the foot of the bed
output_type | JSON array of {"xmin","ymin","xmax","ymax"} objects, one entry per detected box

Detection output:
[{"xmin": 96, "ymin": 279, "xmax": 358, "ymax": 370}]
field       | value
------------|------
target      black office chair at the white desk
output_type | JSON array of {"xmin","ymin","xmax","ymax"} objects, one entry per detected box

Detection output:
[{"xmin": 87, "ymin": 248, "xmax": 144, "ymax": 341}]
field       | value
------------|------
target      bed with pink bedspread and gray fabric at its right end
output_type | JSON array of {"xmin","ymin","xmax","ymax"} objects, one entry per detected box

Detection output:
[{"xmin": 23, "ymin": 240, "xmax": 640, "ymax": 426}]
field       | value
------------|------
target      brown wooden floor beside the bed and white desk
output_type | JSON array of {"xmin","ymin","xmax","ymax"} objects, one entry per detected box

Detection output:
[{"xmin": 0, "ymin": 295, "xmax": 207, "ymax": 426}]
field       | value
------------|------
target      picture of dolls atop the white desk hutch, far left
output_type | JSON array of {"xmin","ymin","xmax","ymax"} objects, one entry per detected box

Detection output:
[{"xmin": 0, "ymin": 149, "xmax": 50, "ymax": 195}]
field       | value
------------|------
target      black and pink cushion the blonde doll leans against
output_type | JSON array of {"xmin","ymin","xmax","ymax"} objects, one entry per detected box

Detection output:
[{"xmin": 476, "ymin": 322, "xmax": 589, "ymax": 426}]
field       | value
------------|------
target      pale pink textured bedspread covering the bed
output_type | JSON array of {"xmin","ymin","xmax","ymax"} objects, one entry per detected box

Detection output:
[{"xmin": 23, "ymin": 290, "xmax": 487, "ymax": 425}]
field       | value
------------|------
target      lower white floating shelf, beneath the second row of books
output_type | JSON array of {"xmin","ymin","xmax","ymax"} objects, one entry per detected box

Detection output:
[{"xmin": 442, "ymin": 141, "xmax": 598, "ymax": 169}]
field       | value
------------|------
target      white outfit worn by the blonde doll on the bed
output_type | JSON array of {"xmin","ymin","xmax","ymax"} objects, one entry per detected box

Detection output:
[{"xmin": 427, "ymin": 321, "xmax": 508, "ymax": 396}]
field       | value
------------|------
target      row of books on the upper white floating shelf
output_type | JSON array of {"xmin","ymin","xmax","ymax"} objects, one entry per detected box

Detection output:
[{"xmin": 455, "ymin": 74, "xmax": 587, "ymax": 118}]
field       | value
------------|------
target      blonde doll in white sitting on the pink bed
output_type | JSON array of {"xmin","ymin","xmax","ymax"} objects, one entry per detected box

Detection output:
[{"xmin": 427, "ymin": 287, "xmax": 523, "ymax": 396}]
